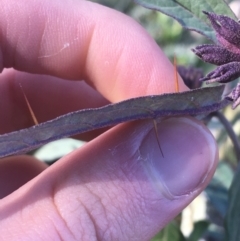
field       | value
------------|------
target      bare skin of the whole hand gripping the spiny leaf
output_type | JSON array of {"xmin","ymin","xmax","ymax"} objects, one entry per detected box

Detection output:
[{"xmin": 0, "ymin": 0, "xmax": 218, "ymax": 241}]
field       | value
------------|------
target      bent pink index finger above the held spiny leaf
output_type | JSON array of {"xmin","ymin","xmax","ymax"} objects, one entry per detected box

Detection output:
[{"xmin": 0, "ymin": 0, "xmax": 186, "ymax": 102}]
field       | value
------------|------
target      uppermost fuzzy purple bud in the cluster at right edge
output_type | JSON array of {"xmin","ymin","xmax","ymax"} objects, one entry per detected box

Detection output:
[{"xmin": 203, "ymin": 11, "xmax": 240, "ymax": 54}]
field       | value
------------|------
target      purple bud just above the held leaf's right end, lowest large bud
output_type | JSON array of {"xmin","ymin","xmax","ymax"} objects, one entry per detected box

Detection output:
[{"xmin": 200, "ymin": 62, "xmax": 240, "ymax": 84}]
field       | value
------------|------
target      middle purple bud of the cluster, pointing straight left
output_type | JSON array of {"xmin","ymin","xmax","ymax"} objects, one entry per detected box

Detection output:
[{"xmin": 192, "ymin": 44, "xmax": 240, "ymax": 65}]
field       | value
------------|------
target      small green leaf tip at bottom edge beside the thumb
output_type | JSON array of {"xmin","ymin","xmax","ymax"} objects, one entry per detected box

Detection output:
[{"xmin": 151, "ymin": 221, "xmax": 186, "ymax": 241}]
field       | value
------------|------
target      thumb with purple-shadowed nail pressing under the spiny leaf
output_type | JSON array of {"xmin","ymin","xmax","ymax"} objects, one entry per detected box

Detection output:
[{"xmin": 0, "ymin": 118, "xmax": 218, "ymax": 240}]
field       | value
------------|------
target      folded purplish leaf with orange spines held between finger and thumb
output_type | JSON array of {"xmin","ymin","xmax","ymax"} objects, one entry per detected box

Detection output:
[{"xmin": 0, "ymin": 85, "xmax": 229, "ymax": 157}]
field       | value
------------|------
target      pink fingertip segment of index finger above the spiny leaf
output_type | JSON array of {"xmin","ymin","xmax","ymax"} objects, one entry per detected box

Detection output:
[{"xmin": 83, "ymin": 1, "xmax": 188, "ymax": 102}]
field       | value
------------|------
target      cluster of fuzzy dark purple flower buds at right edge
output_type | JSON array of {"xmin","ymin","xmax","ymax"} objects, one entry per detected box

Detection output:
[{"xmin": 192, "ymin": 12, "xmax": 240, "ymax": 108}]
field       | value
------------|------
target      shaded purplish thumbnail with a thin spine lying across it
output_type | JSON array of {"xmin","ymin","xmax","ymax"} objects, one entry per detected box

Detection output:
[{"xmin": 139, "ymin": 117, "xmax": 218, "ymax": 199}]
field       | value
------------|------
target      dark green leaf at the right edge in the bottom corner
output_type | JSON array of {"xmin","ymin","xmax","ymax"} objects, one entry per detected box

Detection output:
[{"xmin": 225, "ymin": 166, "xmax": 240, "ymax": 241}]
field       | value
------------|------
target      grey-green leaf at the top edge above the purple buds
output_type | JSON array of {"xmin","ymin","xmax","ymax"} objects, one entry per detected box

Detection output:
[{"xmin": 134, "ymin": 0, "xmax": 236, "ymax": 42}]
